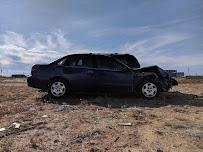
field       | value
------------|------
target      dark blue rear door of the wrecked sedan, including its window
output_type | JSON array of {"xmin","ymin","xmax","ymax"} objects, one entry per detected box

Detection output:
[{"xmin": 63, "ymin": 55, "xmax": 97, "ymax": 92}]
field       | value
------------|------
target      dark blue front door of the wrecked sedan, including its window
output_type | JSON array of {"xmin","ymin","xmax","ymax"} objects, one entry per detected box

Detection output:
[{"xmin": 96, "ymin": 56, "xmax": 133, "ymax": 93}]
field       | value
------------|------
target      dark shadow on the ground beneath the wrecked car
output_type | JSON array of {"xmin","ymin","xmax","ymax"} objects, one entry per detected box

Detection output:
[{"xmin": 38, "ymin": 92, "xmax": 203, "ymax": 108}]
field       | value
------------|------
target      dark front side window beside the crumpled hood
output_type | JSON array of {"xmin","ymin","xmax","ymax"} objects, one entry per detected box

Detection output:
[{"xmin": 96, "ymin": 56, "xmax": 122, "ymax": 70}]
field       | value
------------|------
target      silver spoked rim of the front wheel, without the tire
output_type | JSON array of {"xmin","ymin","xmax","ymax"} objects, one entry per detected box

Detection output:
[{"xmin": 142, "ymin": 82, "xmax": 157, "ymax": 98}]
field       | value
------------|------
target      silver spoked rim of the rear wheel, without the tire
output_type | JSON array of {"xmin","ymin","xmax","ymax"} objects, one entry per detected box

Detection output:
[{"xmin": 51, "ymin": 82, "xmax": 66, "ymax": 97}]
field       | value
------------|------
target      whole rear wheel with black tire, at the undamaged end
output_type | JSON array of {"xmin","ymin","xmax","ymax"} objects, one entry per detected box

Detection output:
[{"xmin": 49, "ymin": 79, "xmax": 69, "ymax": 99}]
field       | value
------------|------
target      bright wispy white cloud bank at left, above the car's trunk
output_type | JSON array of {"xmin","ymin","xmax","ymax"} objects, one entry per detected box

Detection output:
[{"xmin": 0, "ymin": 30, "xmax": 73, "ymax": 65}]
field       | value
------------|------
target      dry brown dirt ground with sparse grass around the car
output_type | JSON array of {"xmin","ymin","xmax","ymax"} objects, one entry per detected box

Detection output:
[{"xmin": 0, "ymin": 78, "xmax": 203, "ymax": 152}]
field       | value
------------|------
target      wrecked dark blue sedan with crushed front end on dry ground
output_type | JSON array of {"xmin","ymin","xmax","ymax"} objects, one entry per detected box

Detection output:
[{"xmin": 27, "ymin": 53, "xmax": 178, "ymax": 99}]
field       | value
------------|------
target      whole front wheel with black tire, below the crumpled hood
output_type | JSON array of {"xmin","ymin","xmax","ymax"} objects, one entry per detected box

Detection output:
[{"xmin": 139, "ymin": 80, "xmax": 160, "ymax": 99}]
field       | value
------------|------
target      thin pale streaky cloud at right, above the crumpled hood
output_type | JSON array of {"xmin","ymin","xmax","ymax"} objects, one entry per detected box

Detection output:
[{"xmin": 121, "ymin": 32, "xmax": 203, "ymax": 66}]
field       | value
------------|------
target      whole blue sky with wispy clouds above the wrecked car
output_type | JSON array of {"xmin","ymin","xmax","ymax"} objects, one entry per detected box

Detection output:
[{"xmin": 0, "ymin": 0, "xmax": 203, "ymax": 74}]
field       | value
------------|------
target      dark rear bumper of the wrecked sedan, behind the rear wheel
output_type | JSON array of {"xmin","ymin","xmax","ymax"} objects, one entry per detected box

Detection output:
[{"xmin": 27, "ymin": 76, "xmax": 48, "ymax": 90}]
